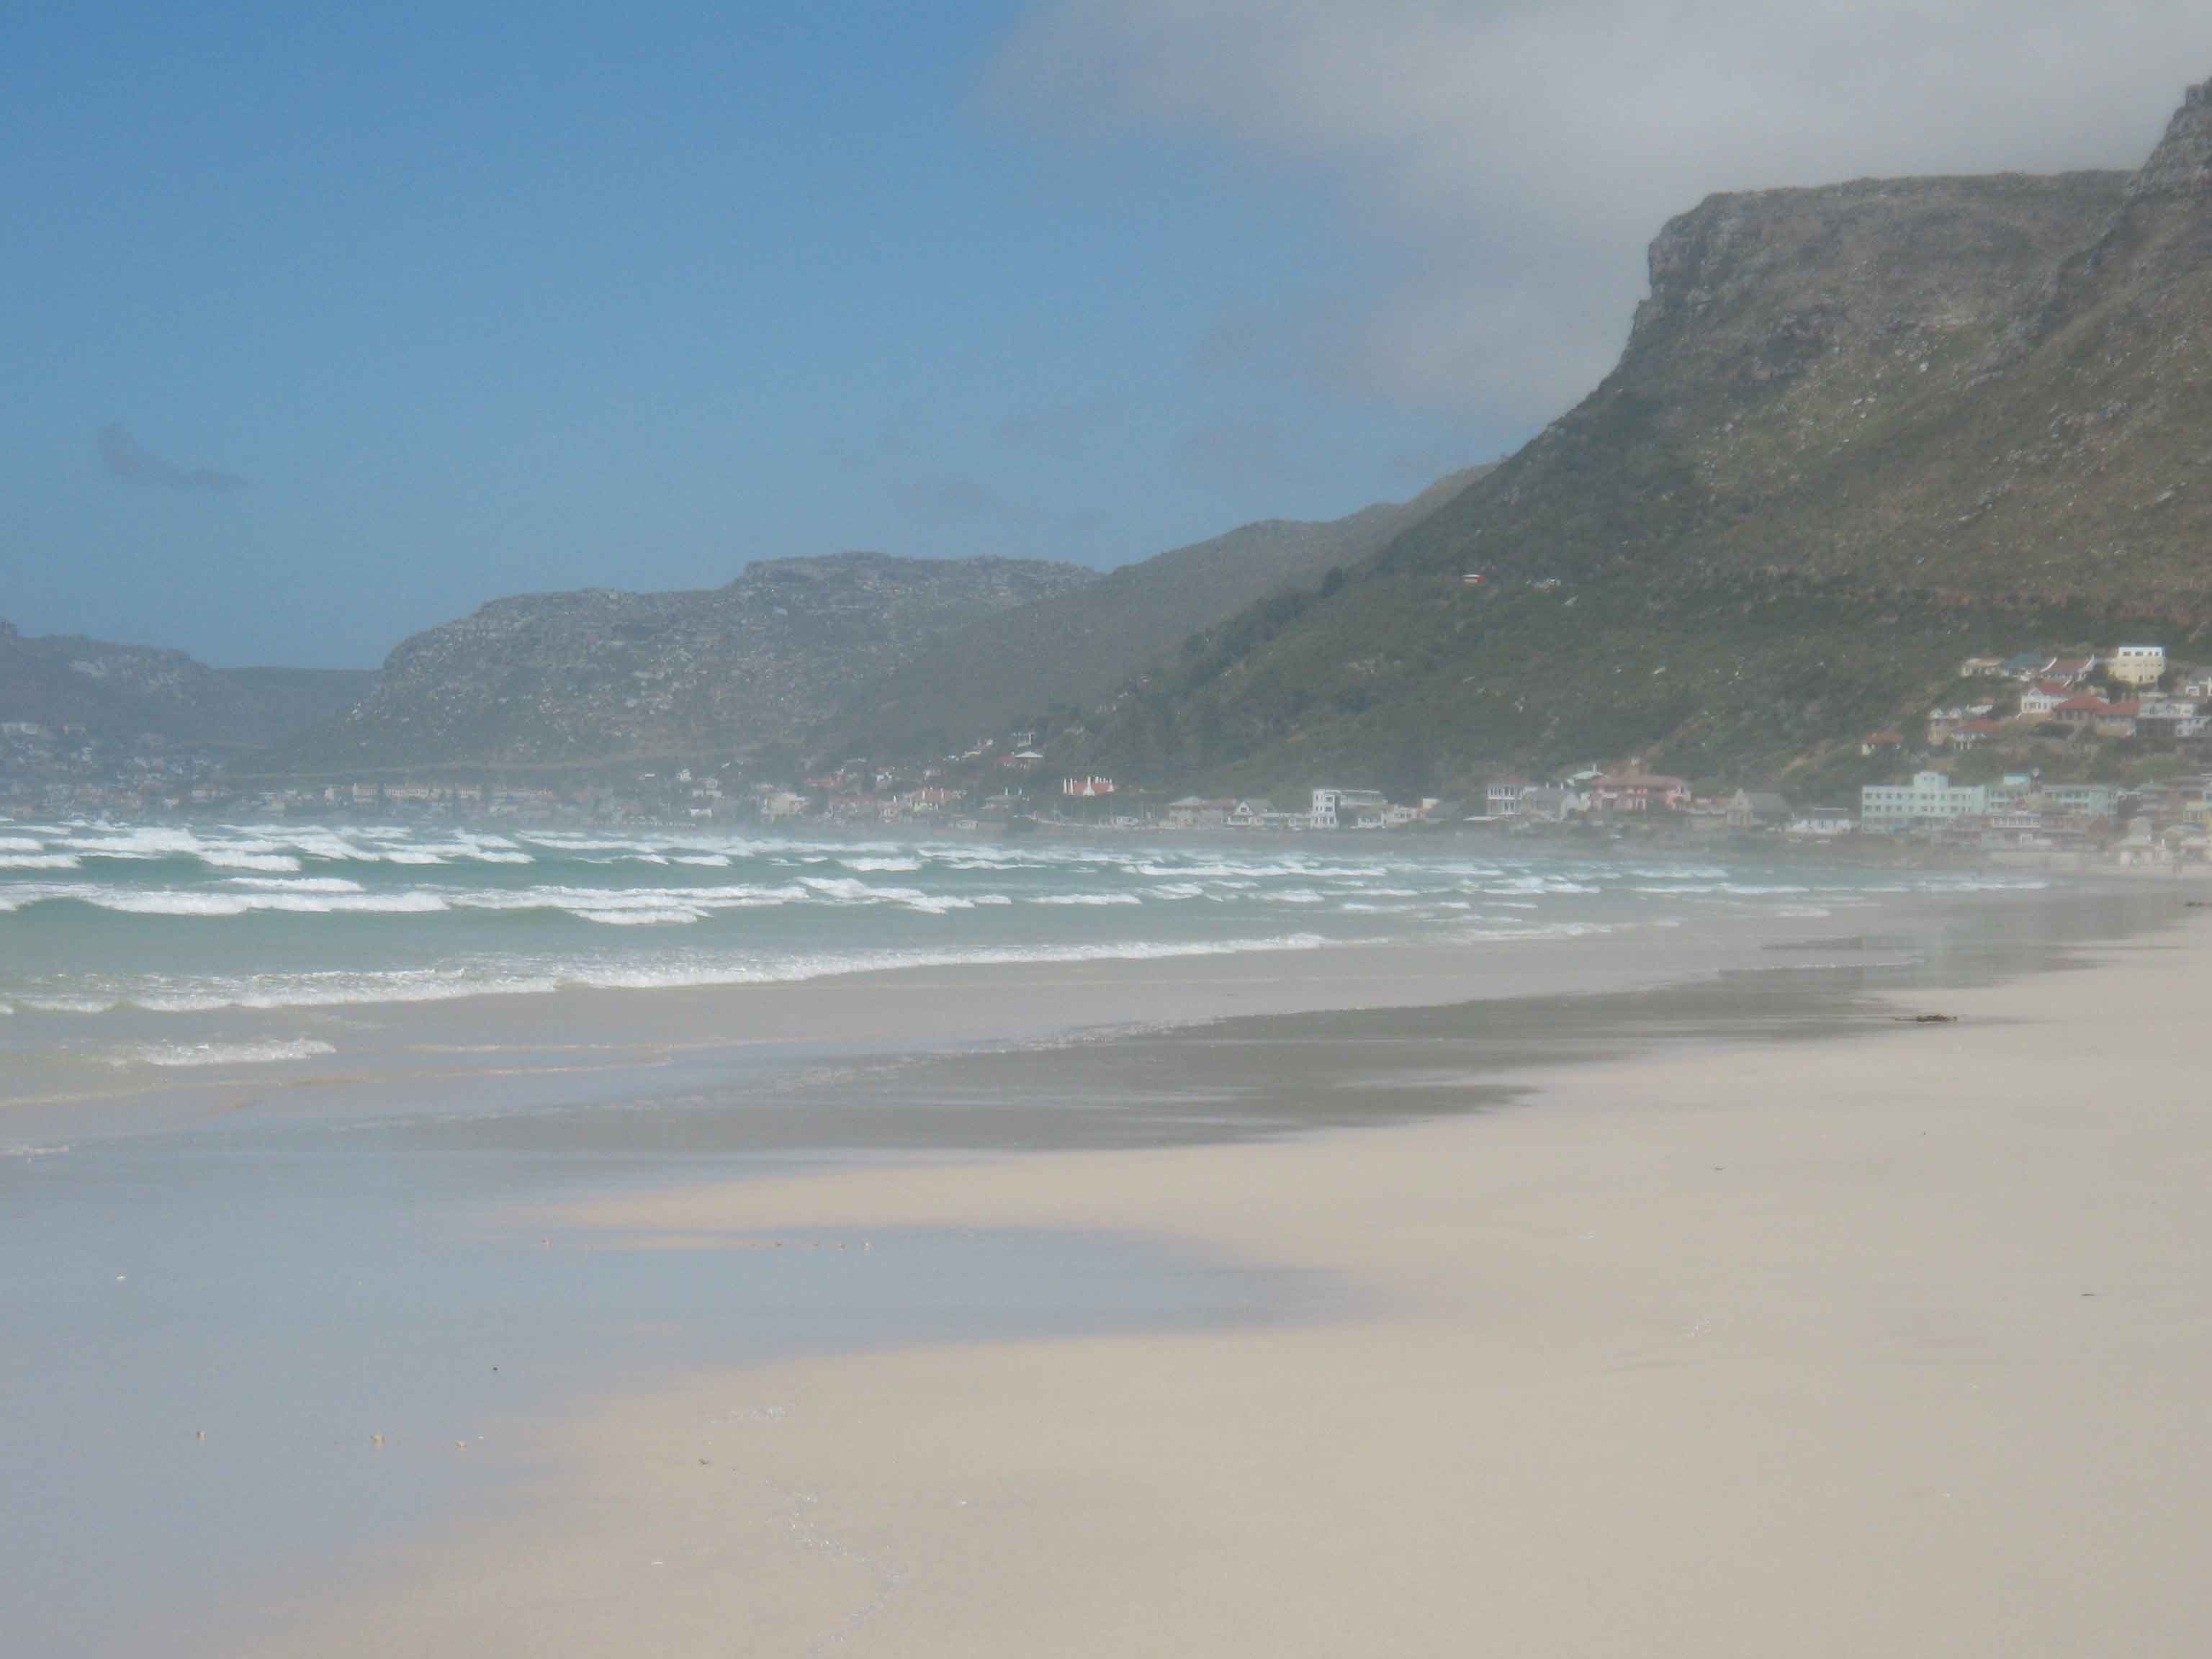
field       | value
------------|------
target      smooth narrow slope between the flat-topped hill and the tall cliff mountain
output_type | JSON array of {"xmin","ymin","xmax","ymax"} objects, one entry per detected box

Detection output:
[{"xmin": 832, "ymin": 467, "xmax": 1486, "ymax": 755}]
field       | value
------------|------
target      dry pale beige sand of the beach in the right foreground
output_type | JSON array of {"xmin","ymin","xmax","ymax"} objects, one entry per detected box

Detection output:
[{"xmin": 246, "ymin": 925, "xmax": 2212, "ymax": 1659}]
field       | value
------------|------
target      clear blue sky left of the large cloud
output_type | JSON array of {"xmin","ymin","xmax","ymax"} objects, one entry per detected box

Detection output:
[{"xmin": 0, "ymin": 4, "xmax": 1498, "ymax": 666}]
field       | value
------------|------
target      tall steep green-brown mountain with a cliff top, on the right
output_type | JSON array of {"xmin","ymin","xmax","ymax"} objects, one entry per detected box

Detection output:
[{"xmin": 1055, "ymin": 89, "xmax": 2212, "ymax": 788}]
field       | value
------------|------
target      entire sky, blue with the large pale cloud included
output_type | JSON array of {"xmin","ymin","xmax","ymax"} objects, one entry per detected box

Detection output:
[{"xmin": 0, "ymin": 0, "xmax": 2212, "ymax": 666}]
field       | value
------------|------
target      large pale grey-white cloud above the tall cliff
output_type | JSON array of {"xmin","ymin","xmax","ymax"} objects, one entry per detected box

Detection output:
[{"xmin": 991, "ymin": 0, "xmax": 2212, "ymax": 425}]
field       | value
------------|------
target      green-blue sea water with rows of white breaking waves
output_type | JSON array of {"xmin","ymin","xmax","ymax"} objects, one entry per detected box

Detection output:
[{"xmin": 0, "ymin": 823, "xmax": 2037, "ymax": 1026}]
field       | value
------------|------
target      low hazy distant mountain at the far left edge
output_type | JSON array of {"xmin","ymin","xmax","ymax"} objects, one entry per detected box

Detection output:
[{"xmin": 0, "ymin": 621, "xmax": 376, "ymax": 750}]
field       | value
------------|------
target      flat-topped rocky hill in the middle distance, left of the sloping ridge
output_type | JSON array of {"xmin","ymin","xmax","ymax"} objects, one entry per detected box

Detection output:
[{"xmin": 274, "ymin": 553, "xmax": 1097, "ymax": 772}]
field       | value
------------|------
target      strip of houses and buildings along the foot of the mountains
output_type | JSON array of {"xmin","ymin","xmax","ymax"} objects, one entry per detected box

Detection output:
[{"xmin": 13, "ymin": 644, "xmax": 2212, "ymax": 863}]
